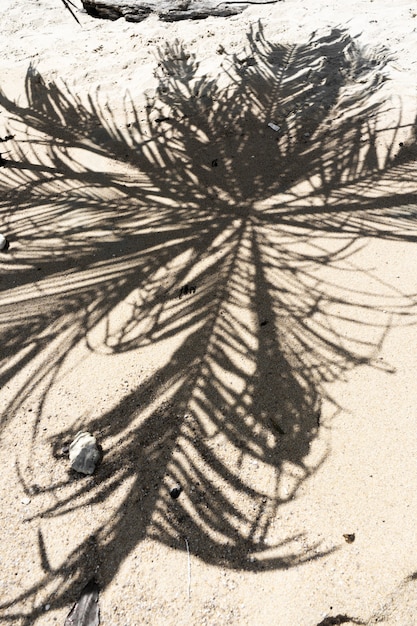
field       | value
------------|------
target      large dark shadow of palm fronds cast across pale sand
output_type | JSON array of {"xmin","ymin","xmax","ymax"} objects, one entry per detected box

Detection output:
[{"xmin": 0, "ymin": 27, "xmax": 416, "ymax": 623}]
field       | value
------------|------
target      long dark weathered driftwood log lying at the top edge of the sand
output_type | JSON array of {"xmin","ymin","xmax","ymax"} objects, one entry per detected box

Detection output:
[{"xmin": 82, "ymin": 0, "xmax": 278, "ymax": 22}]
